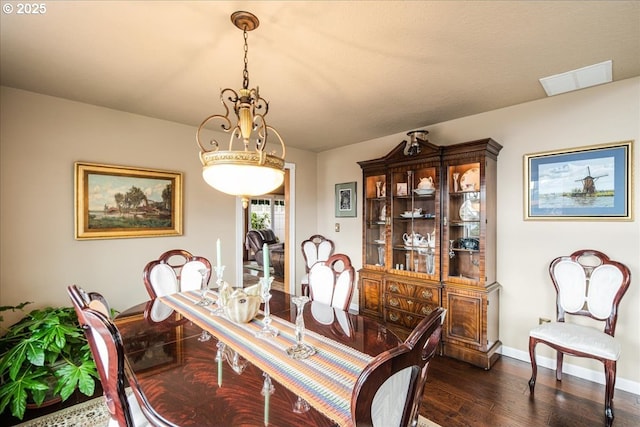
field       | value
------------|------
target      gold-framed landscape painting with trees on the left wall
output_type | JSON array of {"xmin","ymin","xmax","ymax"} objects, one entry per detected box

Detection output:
[{"xmin": 75, "ymin": 162, "xmax": 182, "ymax": 239}]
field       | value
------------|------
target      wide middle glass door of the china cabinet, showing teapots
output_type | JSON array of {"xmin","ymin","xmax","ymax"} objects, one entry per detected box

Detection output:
[{"xmin": 389, "ymin": 166, "xmax": 440, "ymax": 280}]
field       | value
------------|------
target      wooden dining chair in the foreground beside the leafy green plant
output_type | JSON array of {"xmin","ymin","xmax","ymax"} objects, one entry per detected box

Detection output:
[{"xmin": 67, "ymin": 285, "xmax": 151, "ymax": 427}]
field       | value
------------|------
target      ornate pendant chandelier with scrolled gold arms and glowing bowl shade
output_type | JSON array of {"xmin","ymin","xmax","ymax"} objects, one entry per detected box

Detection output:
[{"xmin": 196, "ymin": 11, "xmax": 285, "ymax": 208}]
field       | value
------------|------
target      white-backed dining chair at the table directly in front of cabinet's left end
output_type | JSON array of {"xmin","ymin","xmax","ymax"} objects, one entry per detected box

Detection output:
[{"xmin": 309, "ymin": 254, "xmax": 356, "ymax": 311}]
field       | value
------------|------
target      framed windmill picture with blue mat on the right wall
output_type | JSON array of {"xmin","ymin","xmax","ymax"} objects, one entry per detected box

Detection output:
[{"xmin": 524, "ymin": 141, "xmax": 633, "ymax": 221}]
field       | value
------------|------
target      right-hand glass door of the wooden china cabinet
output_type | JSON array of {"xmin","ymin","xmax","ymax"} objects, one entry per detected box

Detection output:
[{"xmin": 443, "ymin": 162, "xmax": 485, "ymax": 284}]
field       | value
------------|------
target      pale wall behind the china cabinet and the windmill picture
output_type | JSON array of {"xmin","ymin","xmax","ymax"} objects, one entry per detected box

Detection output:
[{"xmin": 318, "ymin": 78, "xmax": 640, "ymax": 394}]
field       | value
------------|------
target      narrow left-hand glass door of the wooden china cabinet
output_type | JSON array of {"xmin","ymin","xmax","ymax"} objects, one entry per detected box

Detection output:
[{"xmin": 363, "ymin": 174, "xmax": 388, "ymax": 268}]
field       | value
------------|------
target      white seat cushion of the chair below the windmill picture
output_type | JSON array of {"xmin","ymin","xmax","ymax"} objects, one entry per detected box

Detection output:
[{"xmin": 529, "ymin": 322, "xmax": 620, "ymax": 360}]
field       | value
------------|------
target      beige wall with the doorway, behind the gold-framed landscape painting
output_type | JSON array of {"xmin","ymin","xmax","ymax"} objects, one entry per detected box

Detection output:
[{"xmin": 0, "ymin": 87, "xmax": 316, "ymax": 319}]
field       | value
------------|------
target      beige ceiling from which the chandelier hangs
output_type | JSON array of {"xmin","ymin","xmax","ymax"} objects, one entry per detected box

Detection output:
[{"xmin": 0, "ymin": 1, "xmax": 640, "ymax": 152}]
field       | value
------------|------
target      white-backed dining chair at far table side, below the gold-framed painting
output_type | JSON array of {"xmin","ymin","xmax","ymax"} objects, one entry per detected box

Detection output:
[{"xmin": 142, "ymin": 249, "xmax": 211, "ymax": 298}]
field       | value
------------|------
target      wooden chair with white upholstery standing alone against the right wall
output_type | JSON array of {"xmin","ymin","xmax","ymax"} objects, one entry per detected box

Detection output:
[{"xmin": 529, "ymin": 249, "xmax": 631, "ymax": 425}]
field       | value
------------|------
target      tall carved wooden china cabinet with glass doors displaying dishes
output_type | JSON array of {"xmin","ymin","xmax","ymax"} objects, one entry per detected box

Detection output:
[{"xmin": 358, "ymin": 135, "xmax": 502, "ymax": 369}]
